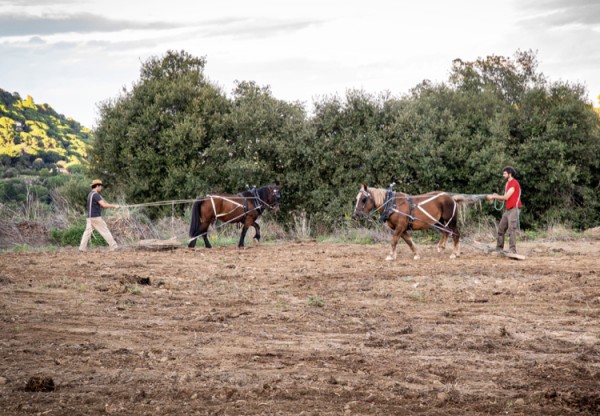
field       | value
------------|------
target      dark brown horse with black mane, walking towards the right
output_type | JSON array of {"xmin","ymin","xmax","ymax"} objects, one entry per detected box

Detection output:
[{"xmin": 188, "ymin": 184, "xmax": 281, "ymax": 248}]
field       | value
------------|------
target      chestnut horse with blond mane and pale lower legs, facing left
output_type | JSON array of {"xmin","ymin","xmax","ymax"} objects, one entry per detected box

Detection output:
[{"xmin": 354, "ymin": 184, "xmax": 460, "ymax": 260}]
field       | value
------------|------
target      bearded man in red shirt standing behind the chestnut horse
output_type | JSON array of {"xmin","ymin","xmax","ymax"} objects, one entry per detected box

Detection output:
[{"xmin": 486, "ymin": 166, "xmax": 522, "ymax": 253}]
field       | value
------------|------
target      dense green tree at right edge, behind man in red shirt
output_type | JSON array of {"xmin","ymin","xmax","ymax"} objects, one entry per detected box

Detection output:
[{"xmin": 515, "ymin": 83, "xmax": 600, "ymax": 228}]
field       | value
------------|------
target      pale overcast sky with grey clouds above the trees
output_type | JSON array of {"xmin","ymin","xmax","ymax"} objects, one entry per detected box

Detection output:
[{"xmin": 0, "ymin": 0, "xmax": 600, "ymax": 128}]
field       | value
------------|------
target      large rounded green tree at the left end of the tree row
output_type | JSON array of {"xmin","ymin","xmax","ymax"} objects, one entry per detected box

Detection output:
[{"xmin": 91, "ymin": 51, "xmax": 230, "ymax": 202}]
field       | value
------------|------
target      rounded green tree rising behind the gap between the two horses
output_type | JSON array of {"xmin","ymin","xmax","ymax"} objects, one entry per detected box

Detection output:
[{"xmin": 287, "ymin": 90, "xmax": 392, "ymax": 224}]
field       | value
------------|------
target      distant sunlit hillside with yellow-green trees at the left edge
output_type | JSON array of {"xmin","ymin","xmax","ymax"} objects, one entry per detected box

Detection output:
[{"xmin": 0, "ymin": 89, "xmax": 92, "ymax": 173}]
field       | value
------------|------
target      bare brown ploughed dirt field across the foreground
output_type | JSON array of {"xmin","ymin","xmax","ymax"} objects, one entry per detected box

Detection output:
[{"xmin": 0, "ymin": 240, "xmax": 600, "ymax": 415}]
